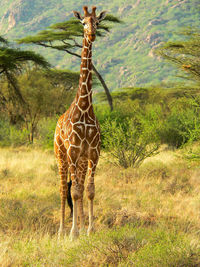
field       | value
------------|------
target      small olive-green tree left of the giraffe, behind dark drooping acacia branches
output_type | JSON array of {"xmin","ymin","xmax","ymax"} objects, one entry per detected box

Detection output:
[{"xmin": 1, "ymin": 68, "xmax": 79, "ymax": 143}]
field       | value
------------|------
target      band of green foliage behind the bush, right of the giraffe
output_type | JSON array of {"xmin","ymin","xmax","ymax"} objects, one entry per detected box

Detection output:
[{"xmin": 97, "ymin": 86, "xmax": 200, "ymax": 151}]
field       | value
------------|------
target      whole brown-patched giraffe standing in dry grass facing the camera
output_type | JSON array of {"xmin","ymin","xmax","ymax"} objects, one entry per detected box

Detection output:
[{"xmin": 54, "ymin": 6, "xmax": 106, "ymax": 240}]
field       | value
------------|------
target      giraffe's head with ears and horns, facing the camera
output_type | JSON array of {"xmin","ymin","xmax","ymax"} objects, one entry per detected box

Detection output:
[{"xmin": 73, "ymin": 6, "xmax": 106, "ymax": 42}]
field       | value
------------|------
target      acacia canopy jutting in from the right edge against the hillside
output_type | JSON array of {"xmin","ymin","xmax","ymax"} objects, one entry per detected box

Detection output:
[{"xmin": 155, "ymin": 30, "xmax": 200, "ymax": 83}]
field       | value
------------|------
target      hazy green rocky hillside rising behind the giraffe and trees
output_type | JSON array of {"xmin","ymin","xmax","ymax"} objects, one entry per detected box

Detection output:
[{"xmin": 0, "ymin": 0, "xmax": 200, "ymax": 89}]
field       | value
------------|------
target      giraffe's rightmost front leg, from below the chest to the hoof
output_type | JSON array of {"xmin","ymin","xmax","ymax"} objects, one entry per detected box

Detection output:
[{"xmin": 87, "ymin": 160, "xmax": 96, "ymax": 235}]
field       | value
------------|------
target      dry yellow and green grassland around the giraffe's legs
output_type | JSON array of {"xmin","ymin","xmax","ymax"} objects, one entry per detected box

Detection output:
[{"xmin": 0, "ymin": 148, "xmax": 200, "ymax": 267}]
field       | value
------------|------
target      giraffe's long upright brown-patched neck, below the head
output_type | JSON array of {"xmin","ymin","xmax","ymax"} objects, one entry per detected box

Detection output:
[{"xmin": 76, "ymin": 37, "xmax": 92, "ymax": 111}]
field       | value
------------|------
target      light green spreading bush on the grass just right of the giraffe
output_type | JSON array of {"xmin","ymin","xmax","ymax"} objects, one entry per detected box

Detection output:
[{"xmin": 101, "ymin": 108, "xmax": 159, "ymax": 168}]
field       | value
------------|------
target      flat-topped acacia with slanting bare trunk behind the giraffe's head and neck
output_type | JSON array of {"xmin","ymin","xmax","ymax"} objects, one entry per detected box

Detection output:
[{"xmin": 18, "ymin": 15, "xmax": 121, "ymax": 110}]
